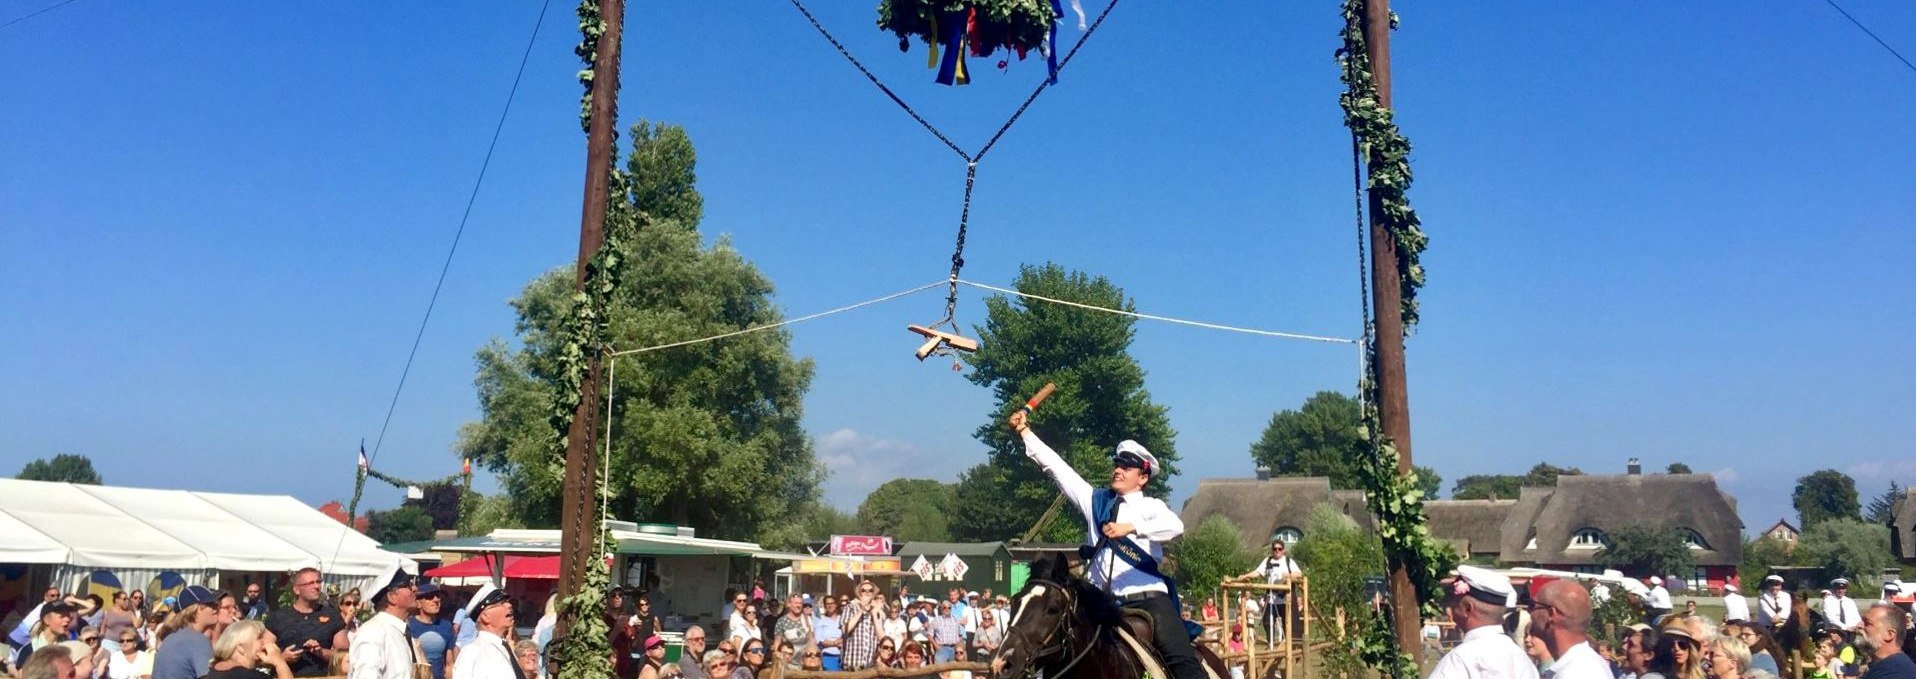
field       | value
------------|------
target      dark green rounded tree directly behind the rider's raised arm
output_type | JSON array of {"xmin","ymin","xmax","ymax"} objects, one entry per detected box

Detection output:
[{"xmin": 952, "ymin": 263, "xmax": 1178, "ymax": 541}]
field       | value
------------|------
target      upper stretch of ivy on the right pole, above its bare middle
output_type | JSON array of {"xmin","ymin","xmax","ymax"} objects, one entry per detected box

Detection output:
[{"xmin": 1337, "ymin": 0, "xmax": 1429, "ymax": 330}]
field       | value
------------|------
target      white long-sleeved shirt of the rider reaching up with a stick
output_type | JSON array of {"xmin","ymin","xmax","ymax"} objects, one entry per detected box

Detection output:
[{"xmin": 1025, "ymin": 430, "xmax": 1184, "ymax": 597}]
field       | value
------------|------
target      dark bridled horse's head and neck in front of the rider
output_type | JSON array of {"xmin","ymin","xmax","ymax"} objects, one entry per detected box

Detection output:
[{"xmin": 991, "ymin": 556, "xmax": 1090, "ymax": 679}]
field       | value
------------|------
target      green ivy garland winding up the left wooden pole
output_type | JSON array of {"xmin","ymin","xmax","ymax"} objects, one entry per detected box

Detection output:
[{"xmin": 548, "ymin": 0, "xmax": 638, "ymax": 679}]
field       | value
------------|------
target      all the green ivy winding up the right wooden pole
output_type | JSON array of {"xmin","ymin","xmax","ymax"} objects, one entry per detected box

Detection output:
[{"xmin": 1337, "ymin": 0, "xmax": 1456, "ymax": 679}]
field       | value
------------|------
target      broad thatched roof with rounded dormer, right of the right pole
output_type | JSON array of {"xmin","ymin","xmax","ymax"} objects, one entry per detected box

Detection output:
[{"xmin": 1498, "ymin": 474, "xmax": 1744, "ymax": 566}]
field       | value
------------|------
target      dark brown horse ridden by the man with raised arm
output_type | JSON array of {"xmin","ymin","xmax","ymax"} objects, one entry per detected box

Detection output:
[{"xmin": 991, "ymin": 558, "xmax": 1230, "ymax": 679}]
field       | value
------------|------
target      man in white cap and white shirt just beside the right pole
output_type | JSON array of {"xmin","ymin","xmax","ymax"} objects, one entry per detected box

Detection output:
[{"xmin": 1429, "ymin": 566, "xmax": 1537, "ymax": 679}]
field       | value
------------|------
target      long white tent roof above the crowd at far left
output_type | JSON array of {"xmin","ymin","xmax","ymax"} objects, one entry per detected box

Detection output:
[{"xmin": 0, "ymin": 480, "xmax": 416, "ymax": 575}]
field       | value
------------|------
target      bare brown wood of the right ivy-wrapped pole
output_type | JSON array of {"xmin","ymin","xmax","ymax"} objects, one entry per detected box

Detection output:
[{"xmin": 1364, "ymin": 0, "xmax": 1424, "ymax": 662}]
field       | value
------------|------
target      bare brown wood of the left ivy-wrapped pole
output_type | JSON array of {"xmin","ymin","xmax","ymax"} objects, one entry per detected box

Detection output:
[{"xmin": 558, "ymin": 0, "xmax": 625, "ymax": 635}]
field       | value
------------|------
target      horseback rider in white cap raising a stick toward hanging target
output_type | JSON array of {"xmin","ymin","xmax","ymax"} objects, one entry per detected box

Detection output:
[{"xmin": 1010, "ymin": 410, "xmax": 1205, "ymax": 679}]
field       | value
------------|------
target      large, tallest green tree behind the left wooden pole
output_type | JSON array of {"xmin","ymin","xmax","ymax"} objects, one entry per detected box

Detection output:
[{"xmin": 456, "ymin": 123, "xmax": 824, "ymax": 543}]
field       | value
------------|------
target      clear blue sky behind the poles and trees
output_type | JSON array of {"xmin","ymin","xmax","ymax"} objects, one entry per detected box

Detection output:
[{"xmin": 0, "ymin": 0, "xmax": 1916, "ymax": 531}]
